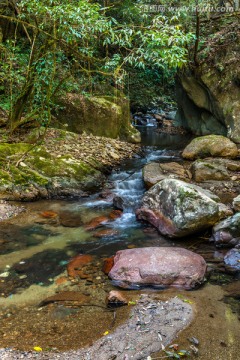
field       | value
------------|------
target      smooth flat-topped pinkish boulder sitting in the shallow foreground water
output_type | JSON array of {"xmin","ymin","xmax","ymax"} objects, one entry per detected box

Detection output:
[{"xmin": 108, "ymin": 247, "xmax": 207, "ymax": 289}]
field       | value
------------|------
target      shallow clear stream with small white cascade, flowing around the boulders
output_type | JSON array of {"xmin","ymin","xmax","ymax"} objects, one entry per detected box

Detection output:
[{"xmin": 0, "ymin": 126, "xmax": 240, "ymax": 360}]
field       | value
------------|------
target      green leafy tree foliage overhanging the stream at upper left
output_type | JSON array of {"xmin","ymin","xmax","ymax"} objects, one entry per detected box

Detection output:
[{"xmin": 0, "ymin": 0, "xmax": 194, "ymax": 131}]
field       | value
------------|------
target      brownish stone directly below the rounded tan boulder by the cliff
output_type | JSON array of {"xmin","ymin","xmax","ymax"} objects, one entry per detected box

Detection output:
[{"xmin": 191, "ymin": 160, "xmax": 230, "ymax": 182}]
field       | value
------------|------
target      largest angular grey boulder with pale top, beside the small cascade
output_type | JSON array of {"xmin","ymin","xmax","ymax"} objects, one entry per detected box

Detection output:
[{"xmin": 136, "ymin": 179, "xmax": 225, "ymax": 237}]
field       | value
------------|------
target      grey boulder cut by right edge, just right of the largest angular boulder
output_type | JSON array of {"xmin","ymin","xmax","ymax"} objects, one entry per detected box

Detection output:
[{"xmin": 210, "ymin": 212, "xmax": 240, "ymax": 247}]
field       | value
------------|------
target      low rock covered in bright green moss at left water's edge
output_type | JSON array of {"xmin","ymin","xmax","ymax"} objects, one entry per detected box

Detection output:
[{"xmin": 0, "ymin": 143, "xmax": 105, "ymax": 201}]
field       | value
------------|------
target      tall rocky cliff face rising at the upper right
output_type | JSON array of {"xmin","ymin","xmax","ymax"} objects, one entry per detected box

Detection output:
[{"xmin": 176, "ymin": 14, "xmax": 240, "ymax": 143}]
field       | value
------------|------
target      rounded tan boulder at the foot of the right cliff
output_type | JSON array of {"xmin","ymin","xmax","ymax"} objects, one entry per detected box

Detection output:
[{"xmin": 182, "ymin": 135, "xmax": 238, "ymax": 160}]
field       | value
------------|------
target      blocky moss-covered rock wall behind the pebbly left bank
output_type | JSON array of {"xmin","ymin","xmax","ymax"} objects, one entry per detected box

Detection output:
[{"xmin": 55, "ymin": 92, "xmax": 141, "ymax": 143}]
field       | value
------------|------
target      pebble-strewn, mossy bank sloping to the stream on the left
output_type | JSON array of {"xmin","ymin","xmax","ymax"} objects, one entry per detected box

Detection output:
[{"xmin": 0, "ymin": 128, "xmax": 140, "ymax": 201}]
